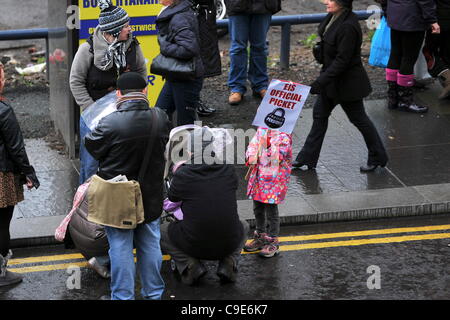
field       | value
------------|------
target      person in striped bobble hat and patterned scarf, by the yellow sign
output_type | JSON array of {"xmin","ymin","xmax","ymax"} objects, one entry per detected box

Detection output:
[{"xmin": 70, "ymin": 0, "xmax": 147, "ymax": 277}]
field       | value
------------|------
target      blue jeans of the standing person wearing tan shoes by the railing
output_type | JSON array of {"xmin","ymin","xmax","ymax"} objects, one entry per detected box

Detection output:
[{"xmin": 228, "ymin": 14, "xmax": 272, "ymax": 94}]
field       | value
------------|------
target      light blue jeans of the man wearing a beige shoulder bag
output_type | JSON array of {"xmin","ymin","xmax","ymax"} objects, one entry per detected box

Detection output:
[{"xmin": 105, "ymin": 219, "xmax": 164, "ymax": 300}]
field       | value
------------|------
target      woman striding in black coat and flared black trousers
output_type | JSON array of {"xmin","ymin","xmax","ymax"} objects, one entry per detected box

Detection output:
[{"xmin": 292, "ymin": 0, "xmax": 388, "ymax": 172}]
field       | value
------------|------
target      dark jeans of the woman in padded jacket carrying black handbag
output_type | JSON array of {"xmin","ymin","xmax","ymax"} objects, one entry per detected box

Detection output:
[{"xmin": 155, "ymin": 78, "xmax": 203, "ymax": 127}]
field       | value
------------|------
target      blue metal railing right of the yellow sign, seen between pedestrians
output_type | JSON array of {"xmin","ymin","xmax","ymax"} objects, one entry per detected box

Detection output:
[{"xmin": 217, "ymin": 10, "xmax": 381, "ymax": 70}]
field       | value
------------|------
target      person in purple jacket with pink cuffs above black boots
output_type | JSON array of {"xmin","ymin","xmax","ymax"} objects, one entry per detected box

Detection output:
[{"xmin": 377, "ymin": 0, "xmax": 440, "ymax": 113}]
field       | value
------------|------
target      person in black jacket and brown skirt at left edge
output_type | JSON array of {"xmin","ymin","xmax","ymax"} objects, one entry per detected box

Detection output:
[{"xmin": 0, "ymin": 63, "xmax": 39, "ymax": 287}]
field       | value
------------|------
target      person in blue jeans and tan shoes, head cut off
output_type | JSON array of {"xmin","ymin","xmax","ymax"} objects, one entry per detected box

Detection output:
[{"xmin": 225, "ymin": 0, "xmax": 281, "ymax": 105}]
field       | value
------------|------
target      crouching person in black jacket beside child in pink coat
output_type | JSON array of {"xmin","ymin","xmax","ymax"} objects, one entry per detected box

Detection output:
[{"xmin": 161, "ymin": 129, "xmax": 249, "ymax": 285}]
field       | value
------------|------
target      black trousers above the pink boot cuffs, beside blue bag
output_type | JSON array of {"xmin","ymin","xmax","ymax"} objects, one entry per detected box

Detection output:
[{"xmin": 387, "ymin": 29, "xmax": 425, "ymax": 75}]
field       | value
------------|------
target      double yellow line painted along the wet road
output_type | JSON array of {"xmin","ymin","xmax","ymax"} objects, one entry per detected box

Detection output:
[{"xmin": 9, "ymin": 224, "xmax": 450, "ymax": 273}]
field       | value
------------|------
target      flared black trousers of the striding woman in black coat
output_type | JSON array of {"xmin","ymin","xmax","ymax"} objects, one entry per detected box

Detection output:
[{"xmin": 296, "ymin": 94, "xmax": 388, "ymax": 167}]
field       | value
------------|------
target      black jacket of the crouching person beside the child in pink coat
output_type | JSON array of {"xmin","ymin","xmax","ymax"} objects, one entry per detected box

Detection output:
[{"xmin": 168, "ymin": 162, "xmax": 243, "ymax": 260}]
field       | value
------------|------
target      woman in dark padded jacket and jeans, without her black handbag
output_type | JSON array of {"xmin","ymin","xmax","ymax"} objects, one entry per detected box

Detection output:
[{"xmin": 156, "ymin": 0, "xmax": 204, "ymax": 126}]
